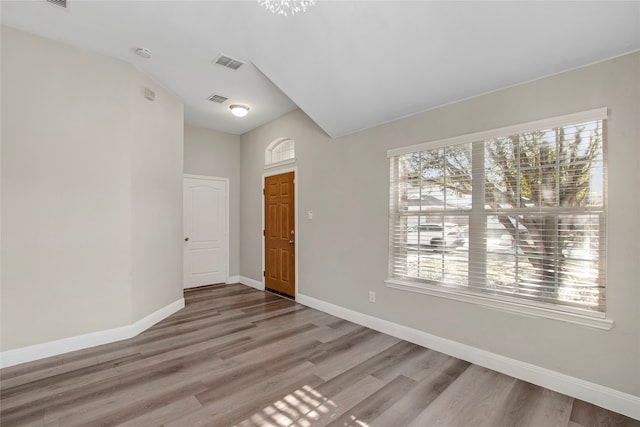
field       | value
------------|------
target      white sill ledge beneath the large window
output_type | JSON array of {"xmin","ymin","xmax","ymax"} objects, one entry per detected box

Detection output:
[{"xmin": 384, "ymin": 278, "xmax": 613, "ymax": 331}]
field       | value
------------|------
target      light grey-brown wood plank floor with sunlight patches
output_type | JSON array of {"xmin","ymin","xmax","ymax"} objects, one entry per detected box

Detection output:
[{"xmin": 0, "ymin": 285, "xmax": 640, "ymax": 427}]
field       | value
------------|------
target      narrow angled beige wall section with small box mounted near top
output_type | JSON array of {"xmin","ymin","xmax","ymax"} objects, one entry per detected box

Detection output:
[{"xmin": 131, "ymin": 70, "xmax": 184, "ymax": 321}]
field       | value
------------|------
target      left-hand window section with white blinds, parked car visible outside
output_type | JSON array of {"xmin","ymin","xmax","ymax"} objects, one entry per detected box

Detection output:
[{"xmin": 390, "ymin": 144, "xmax": 471, "ymax": 286}]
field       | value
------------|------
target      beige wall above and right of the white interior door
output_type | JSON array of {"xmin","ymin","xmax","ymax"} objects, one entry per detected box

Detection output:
[{"xmin": 184, "ymin": 125, "xmax": 240, "ymax": 276}]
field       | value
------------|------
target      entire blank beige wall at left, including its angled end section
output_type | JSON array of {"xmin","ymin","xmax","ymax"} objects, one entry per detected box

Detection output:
[{"xmin": 0, "ymin": 27, "xmax": 183, "ymax": 351}]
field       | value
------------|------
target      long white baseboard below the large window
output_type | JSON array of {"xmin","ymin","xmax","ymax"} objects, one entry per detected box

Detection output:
[{"xmin": 296, "ymin": 294, "xmax": 640, "ymax": 420}]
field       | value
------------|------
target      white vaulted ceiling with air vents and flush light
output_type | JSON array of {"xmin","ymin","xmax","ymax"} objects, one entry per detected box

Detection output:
[{"xmin": 0, "ymin": 0, "xmax": 640, "ymax": 137}]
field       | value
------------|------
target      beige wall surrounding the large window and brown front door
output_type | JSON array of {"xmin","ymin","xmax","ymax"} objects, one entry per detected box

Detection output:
[{"xmin": 240, "ymin": 53, "xmax": 640, "ymax": 396}]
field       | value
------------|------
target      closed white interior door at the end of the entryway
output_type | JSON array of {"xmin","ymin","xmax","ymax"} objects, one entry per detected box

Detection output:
[{"xmin": 184, "ymin": 177, "xmax": 228, "ymax": 288}]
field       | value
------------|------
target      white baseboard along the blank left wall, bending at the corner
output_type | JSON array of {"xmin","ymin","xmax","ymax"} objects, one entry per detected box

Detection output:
[{"xmin": 0, "ymin": 298, "xmax": 184, "ymax": 368}]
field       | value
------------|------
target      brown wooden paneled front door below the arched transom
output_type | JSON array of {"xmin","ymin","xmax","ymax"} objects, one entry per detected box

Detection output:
[{"xmin": 264, "ymin": 172, "xmax": 296, "ymax": 297}]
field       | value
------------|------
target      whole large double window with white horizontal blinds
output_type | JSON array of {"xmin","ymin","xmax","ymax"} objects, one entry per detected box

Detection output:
[{"xmin": 388, "ymin": 108, "xmax": 607, "ymax": 313}]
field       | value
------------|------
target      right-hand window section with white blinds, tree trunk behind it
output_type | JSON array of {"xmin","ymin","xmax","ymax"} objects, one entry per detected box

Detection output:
[{"xmin": 484, "ymin": 120, "xmax": 606, "ymax": 311}]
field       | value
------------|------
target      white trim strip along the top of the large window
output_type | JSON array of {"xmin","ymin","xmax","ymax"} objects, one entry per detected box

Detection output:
[{"xmin": 387, "ymin": 107, "xmax": 607, "ymax": 157}]
